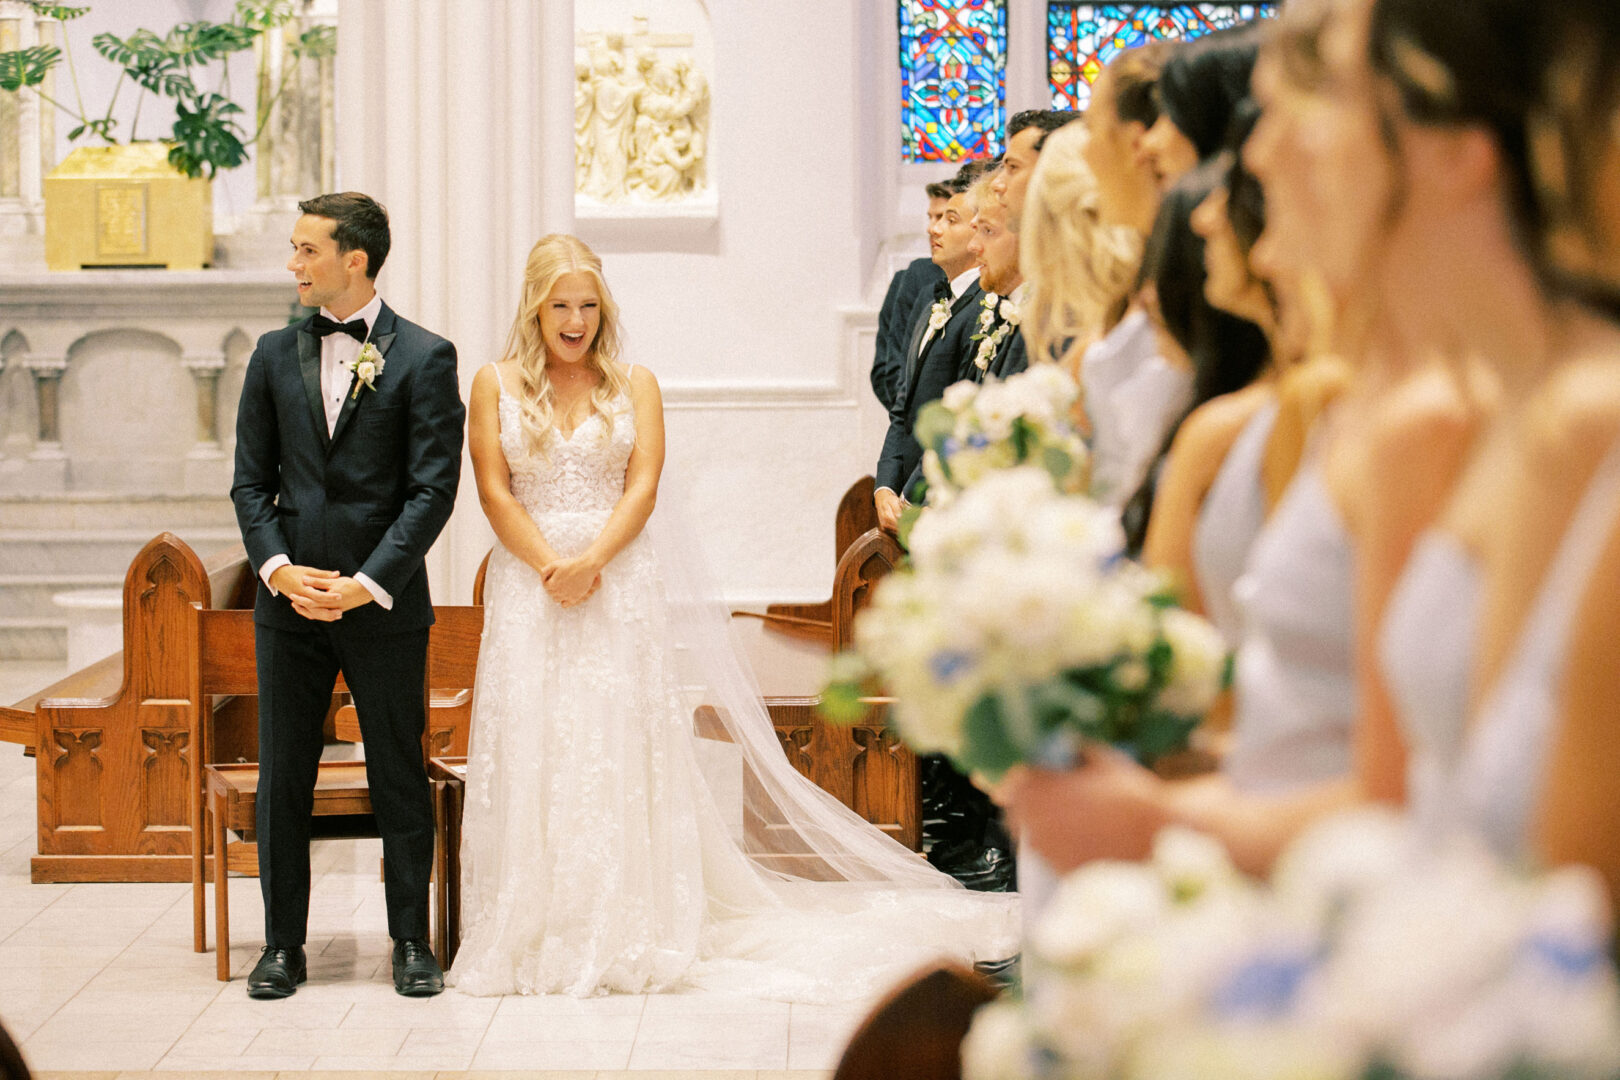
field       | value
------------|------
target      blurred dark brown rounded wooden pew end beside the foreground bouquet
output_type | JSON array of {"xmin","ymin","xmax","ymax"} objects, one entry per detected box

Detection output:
[{"xmin": 833, "ymin": 963, "xmax": 996, "ymax": 1080}]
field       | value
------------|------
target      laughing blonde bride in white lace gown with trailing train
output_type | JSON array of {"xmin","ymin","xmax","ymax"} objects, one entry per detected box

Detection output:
[{"xmin": 449, "ymin": 235, "xmax": 1017, "ymax": 1001}]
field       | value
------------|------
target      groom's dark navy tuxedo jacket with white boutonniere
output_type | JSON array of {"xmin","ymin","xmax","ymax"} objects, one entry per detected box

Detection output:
[{"xmin": 230, "ymin": 304, "xmax": 467, "ymax": 635}]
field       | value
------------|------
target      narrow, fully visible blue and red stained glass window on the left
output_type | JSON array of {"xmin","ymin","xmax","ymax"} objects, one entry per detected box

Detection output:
[{"xmin": 899, "ymin": 0, "xmax": 1008, "ymax": 162}]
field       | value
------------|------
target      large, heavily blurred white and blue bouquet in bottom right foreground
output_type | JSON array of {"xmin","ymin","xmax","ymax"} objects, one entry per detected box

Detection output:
[{"xmin": 962, "ymin": 811, "xmax": 1620, "ymax": 1080}]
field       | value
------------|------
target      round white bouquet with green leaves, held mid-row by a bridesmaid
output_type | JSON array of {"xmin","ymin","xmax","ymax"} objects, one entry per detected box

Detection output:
[{"xmin": 823, "ymin": 465, "xmax": 1226, "ymax": 779}]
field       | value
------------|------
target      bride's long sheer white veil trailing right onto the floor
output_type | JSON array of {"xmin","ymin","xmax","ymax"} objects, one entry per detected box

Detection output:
[{"xmin": 648, "ymin": 476, "xmax": 1019, "ymax": 1001}]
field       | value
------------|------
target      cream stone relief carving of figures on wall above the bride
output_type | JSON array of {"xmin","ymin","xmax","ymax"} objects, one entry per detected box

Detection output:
[{"xmin": 573, "ymin": 18, "xmax": 710, "ymax": 202}]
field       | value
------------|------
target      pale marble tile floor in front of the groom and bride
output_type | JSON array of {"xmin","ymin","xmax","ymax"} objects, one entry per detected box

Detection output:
[{"xmin": 0, "ymin": 663, "xmax": 865, "ymax": 1080}]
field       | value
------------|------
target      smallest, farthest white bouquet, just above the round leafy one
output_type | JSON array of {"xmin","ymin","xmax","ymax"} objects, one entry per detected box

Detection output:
[{"xmin": 915, "ymin": 364, "xmax": 1089, "ymax": 507}]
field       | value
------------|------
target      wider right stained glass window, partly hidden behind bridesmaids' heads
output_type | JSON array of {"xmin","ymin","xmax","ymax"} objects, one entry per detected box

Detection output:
[{"xmin": 1047, "ymin": 0, "xmax": 1277, "ymax": 108}]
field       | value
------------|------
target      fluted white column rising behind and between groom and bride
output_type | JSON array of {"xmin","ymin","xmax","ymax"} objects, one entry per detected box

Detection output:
[{"xmin": 337, "ymin": 0, "xmax": 573, "ymax": 604}]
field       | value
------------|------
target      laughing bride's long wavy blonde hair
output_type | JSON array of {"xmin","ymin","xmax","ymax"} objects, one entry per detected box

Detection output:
[{"xmin": 501, "ymin": 233, "xmax": 630, "ymax": 453}]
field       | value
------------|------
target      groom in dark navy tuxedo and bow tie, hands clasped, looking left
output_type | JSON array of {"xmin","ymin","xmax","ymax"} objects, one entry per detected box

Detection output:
[{"xmin": 230, "ymin": 191, "xmax": 467, "ymax": 997}]
